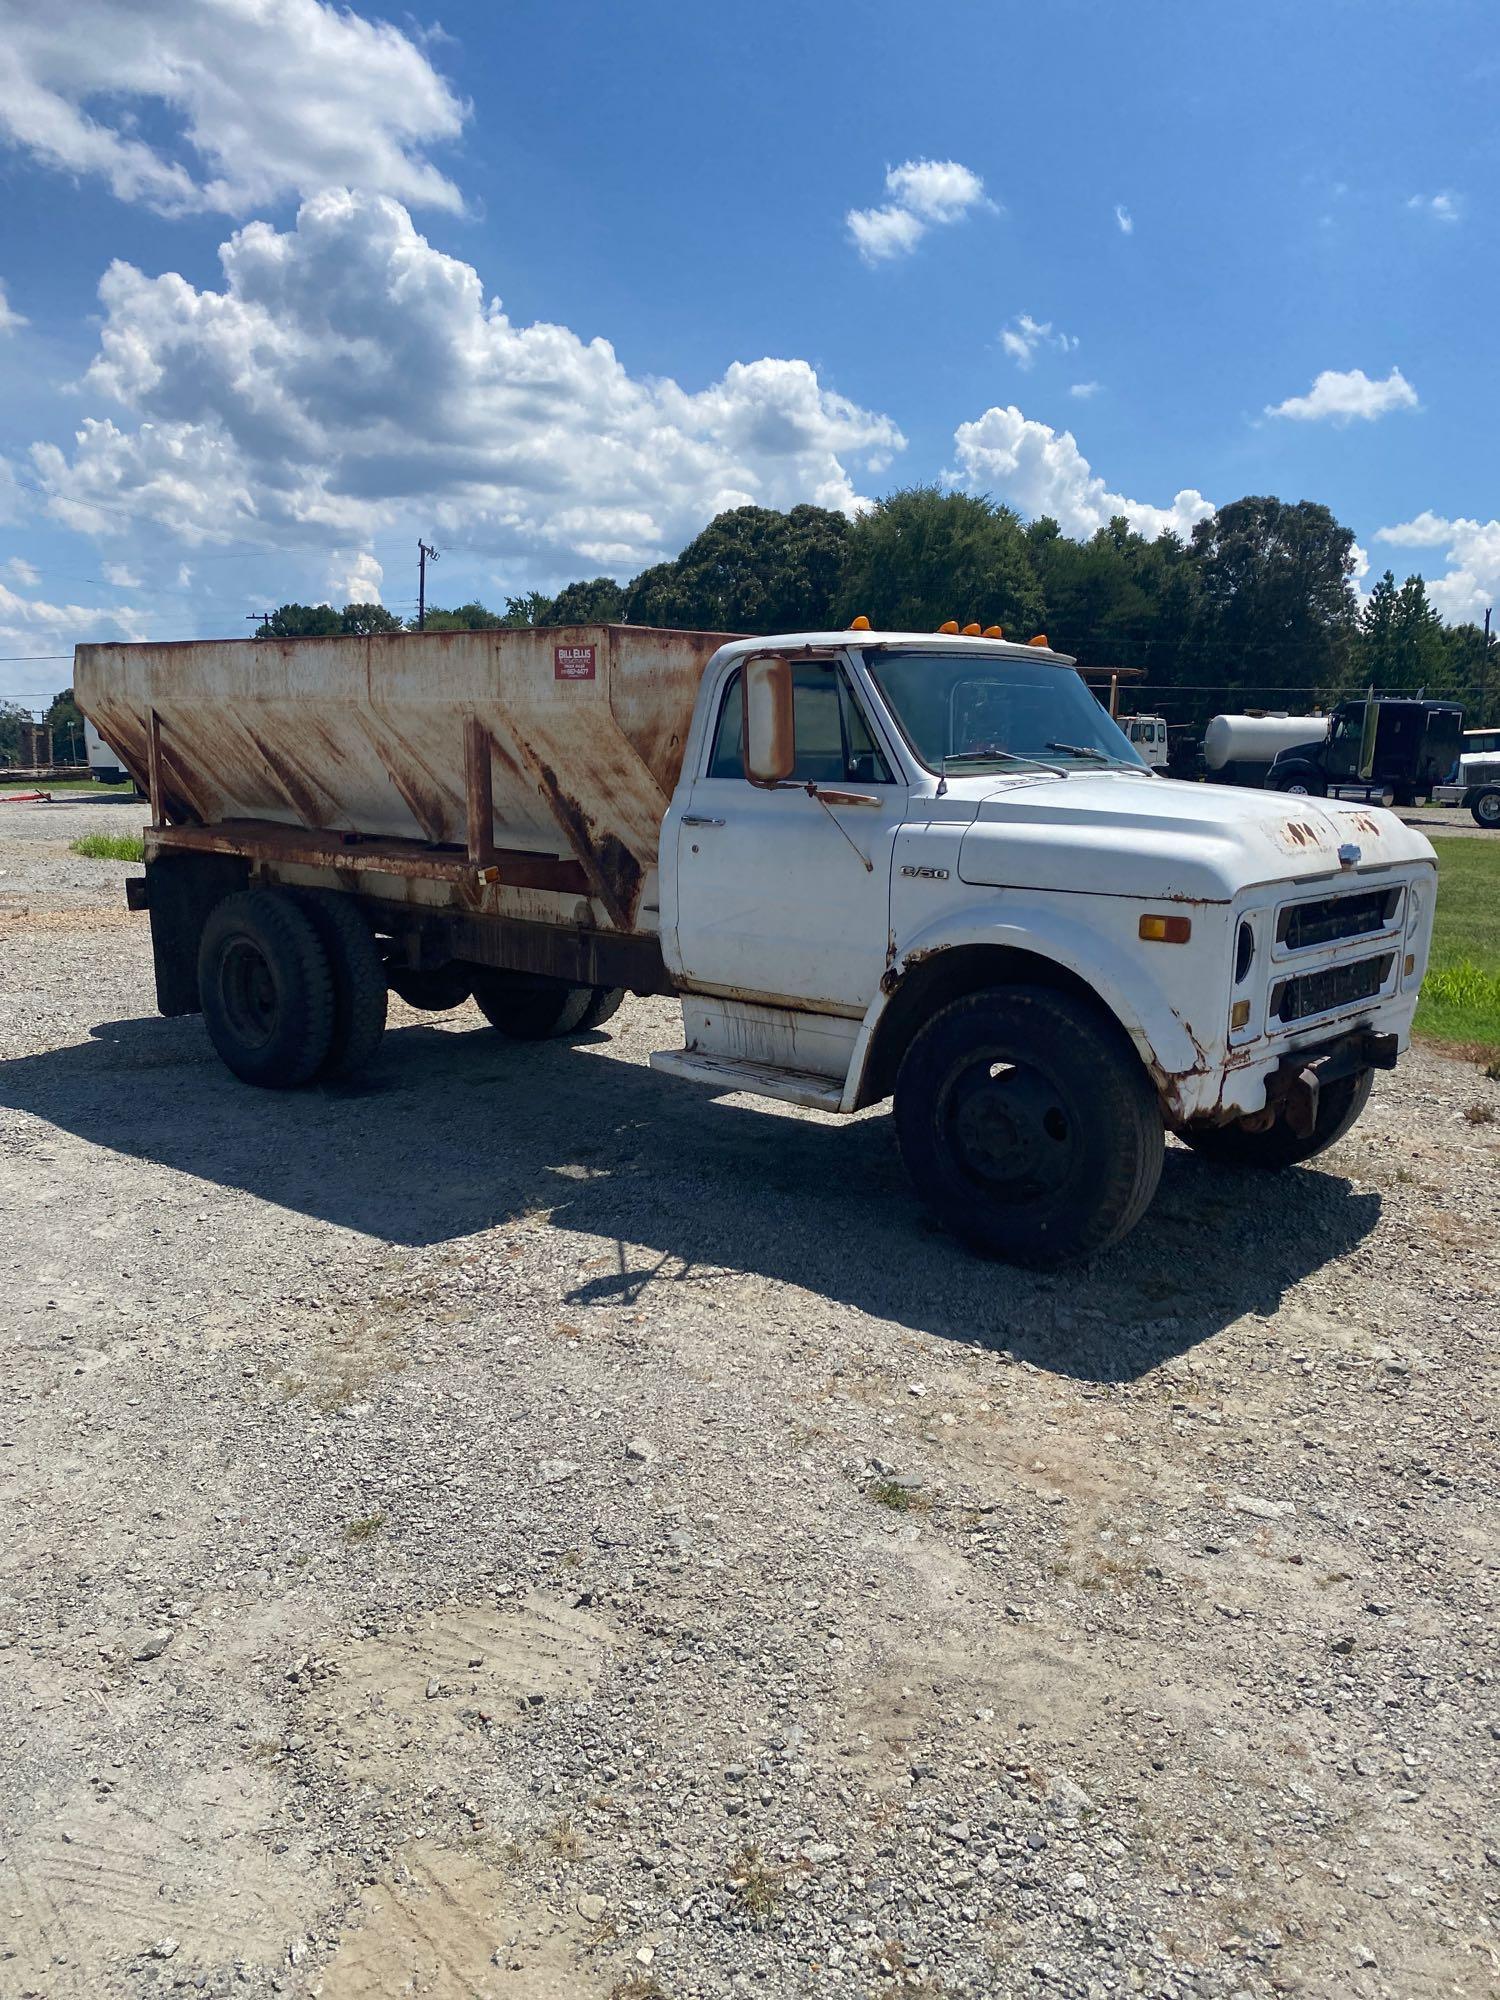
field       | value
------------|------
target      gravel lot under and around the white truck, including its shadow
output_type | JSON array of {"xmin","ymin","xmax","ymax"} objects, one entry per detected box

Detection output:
[{"xmin": 0, "ymin": 802, "xmax": 1500, "ymax": 2000}]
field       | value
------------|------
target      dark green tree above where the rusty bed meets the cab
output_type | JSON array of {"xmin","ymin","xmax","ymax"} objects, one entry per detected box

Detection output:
[{"xmin": 624, "ymin": 506, "xmax": 850, "ymax": 632}]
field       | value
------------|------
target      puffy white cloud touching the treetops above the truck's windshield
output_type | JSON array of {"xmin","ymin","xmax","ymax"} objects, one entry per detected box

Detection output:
[{"xmin": 948, "ymin": 404, "xmax": 1214, "ymax": 538}]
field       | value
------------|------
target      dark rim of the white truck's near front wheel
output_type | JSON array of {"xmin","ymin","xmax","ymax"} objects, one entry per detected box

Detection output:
[{"xmin": 940, "ymin": 1050, "xmax": 1078, "ymax": 1204}]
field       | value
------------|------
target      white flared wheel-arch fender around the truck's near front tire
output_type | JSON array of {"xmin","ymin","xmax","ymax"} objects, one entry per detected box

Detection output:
[{"xmin": 842, "ymin": 896, "xmax": 1222, "ymax": 1110}]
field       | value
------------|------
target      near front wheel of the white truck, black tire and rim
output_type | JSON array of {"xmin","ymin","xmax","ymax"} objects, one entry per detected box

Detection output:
[{"xmin": 896, "ymin": 986, "xmax": 1164, "ymax": 1268}]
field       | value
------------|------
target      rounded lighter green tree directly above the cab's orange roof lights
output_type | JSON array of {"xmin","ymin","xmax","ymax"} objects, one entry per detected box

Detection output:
[{"xmin": 836, "ymin": 486, "xmax": 1044, "ymax": 638}]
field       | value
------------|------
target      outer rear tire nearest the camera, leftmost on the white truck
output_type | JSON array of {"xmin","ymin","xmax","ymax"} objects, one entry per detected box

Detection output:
[{"xmin": 198, "ymin": 888, "xmax": 334, "ymax": 1090}]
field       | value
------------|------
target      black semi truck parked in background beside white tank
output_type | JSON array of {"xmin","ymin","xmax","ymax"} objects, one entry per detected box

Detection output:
[{"xmin": 1266, "ymin": 696, "xmax": 1464, "ymax": 806}]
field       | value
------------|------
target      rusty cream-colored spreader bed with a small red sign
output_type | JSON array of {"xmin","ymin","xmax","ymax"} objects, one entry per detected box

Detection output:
[{"xmin": 74, "ymin": 626, "xmax": 730, "ymax": 932}]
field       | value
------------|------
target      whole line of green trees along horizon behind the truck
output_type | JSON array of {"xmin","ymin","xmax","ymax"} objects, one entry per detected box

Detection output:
[{"xmin": 250, "ymin": 486, "xmax": 1500, "ymax": 724}]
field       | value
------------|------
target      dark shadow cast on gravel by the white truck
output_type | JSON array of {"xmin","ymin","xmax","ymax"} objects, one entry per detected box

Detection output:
[{"xmin": 0, "ymin": 1018, "xmax": 1380, "ymax": 1382}]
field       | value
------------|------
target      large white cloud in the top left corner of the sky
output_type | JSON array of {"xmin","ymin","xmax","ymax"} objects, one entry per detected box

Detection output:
[{"xmin": 0, "ymin": 0, "xmax": 468, "ymax": 216}]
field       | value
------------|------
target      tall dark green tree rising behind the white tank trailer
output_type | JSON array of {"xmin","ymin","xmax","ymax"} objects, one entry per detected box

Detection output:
[{"xmin": 1192, "ymin": 494, "xmax": 1356, "ymax": 692}]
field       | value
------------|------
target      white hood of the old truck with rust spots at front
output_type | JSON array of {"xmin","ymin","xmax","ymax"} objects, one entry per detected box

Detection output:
[{"xmin": 958, "ymin": 772, "xmax": 1434, "ymax": 902}]
